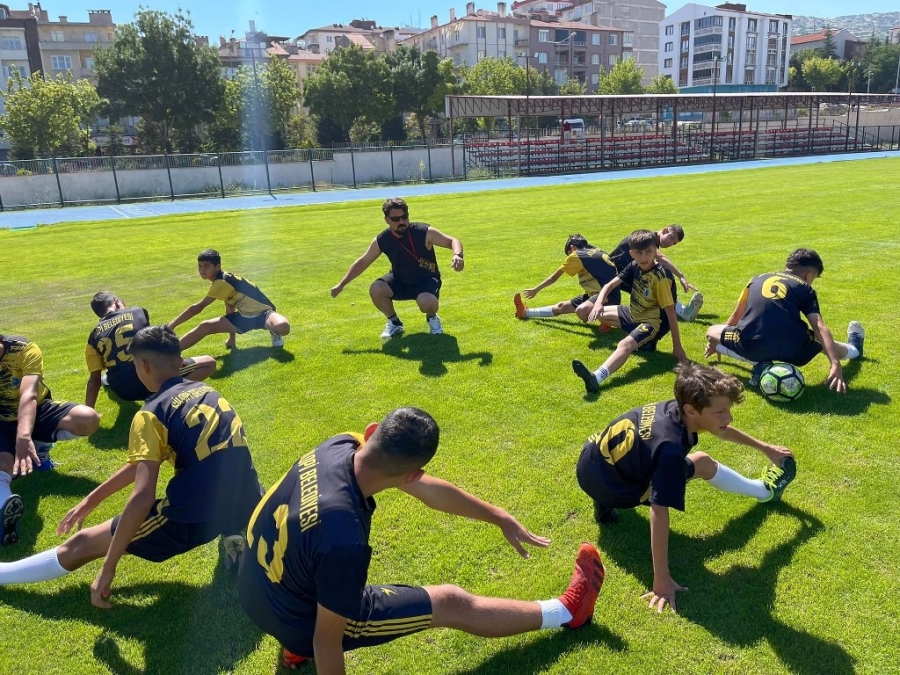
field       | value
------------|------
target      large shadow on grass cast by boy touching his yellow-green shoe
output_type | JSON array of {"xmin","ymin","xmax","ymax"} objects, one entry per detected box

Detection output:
[{"xmin": 601, "ymin": 502, "xmax": 855, "ymax": 675}]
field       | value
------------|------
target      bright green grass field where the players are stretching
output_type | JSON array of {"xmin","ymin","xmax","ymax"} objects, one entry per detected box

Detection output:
[{"xmin": 0, "ymin": 159, "xmax": 900, "ymax": 675}]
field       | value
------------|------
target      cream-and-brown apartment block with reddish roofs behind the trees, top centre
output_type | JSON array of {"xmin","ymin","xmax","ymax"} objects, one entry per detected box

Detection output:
[{"xmin": 404, "ymin": 2, "xmax": 631, "ymax": 93}]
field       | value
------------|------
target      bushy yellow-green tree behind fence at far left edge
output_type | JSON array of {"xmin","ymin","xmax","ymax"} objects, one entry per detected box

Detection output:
[{"xmin": 0, "ymin": 72, "xmax": 101, "ymax": 159}]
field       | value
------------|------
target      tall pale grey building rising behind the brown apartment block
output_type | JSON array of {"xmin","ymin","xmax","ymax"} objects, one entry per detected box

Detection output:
[{"xmin": 560, "ymin": 0, "xmax": 666, "ymax": 86}]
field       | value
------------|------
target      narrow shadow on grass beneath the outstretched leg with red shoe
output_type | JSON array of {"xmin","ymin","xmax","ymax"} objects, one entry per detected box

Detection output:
[{"xmin": 448, "ymin": 623, "xmax": 628, "ymax": 675}]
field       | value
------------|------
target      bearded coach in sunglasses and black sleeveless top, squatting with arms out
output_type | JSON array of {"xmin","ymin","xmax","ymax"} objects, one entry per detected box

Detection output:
[{"xmin": 331, "ymin": 198, "xmax": 464, "ymax": 339}]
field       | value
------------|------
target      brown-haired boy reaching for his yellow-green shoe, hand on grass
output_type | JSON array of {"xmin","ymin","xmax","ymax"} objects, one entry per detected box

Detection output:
[{"xmin": 576, "ymin": 364, "xmax": 797, "ymax": 612}]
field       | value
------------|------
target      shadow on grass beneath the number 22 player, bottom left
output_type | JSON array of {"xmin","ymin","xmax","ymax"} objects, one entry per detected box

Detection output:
[{"xmin": 3, "ymin": 565, "xmax": 263, "ymax": 675}]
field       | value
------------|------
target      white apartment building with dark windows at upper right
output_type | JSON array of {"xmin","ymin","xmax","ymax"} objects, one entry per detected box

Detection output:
[{"xmin": 659, "ymin": 3, "xmax": 792, "ymax": 92}]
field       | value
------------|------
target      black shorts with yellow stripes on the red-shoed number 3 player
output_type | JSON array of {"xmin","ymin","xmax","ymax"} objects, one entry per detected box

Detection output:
[{"xmin": 241, "ymin": 585, "xmax": 431, "ymax": 658}]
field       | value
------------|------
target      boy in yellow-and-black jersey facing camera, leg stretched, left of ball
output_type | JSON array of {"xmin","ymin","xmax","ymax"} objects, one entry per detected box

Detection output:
[{"xmin": 572, "ymin": 230, "xmax": 687, "ymax": 394}]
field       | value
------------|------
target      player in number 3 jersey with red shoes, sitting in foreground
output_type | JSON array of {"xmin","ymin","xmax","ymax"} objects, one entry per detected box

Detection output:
[{"xmin": 238, "ymin": 408, "xmax": 604, "ymax": 674}]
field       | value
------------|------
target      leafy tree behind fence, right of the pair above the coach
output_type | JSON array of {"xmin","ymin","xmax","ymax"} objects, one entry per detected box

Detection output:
[{"xmin": 384, "ymin": 45, "xmax": 456, "ymax": 138}]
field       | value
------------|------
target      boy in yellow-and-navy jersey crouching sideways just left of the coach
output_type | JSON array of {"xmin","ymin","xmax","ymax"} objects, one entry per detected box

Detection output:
[{"xmin": 169, "ymin": 248, "xmax": 291, "ymax": 350}]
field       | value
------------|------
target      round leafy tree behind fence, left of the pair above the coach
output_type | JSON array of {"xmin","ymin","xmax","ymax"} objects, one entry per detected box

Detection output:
[{"xmin": 303, "ymin": 44, "xmax": 394, "ymax": 142}]
